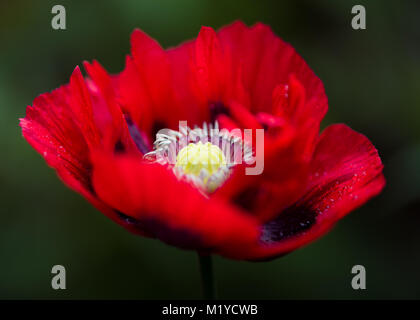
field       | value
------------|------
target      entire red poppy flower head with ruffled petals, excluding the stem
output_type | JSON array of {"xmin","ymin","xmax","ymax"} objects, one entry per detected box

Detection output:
[{"xmin": 21, "ymin": 22, "xmax": 385, "ymax": 260}]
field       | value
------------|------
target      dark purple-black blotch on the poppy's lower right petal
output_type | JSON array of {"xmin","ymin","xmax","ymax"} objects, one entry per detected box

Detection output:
[{"xmin": 260, "ymin": 205, "xmax": 317, "ymax": 244}]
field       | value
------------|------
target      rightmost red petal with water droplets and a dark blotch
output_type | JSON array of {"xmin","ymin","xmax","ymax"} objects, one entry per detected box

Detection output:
[{"xmin": 241, "ymin": 124, "xmax": 385, "ymax": 259}]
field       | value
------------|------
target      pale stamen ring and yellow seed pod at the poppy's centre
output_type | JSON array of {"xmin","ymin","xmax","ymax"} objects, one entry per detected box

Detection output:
[{"xmin": 144, "ymin": 122, "xmax": 252, "ymax": 195}]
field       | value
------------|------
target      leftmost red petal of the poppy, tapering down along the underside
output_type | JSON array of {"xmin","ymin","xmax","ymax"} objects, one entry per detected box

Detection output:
[{"xmin": 20, "ymin": 68, "xmax": 150, "ymax": 234}]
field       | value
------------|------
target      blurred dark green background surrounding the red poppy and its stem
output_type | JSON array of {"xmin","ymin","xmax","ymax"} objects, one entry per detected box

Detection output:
[{"xmin": 0, "ymin": 0, "xmax": 420, "ymax": 299}]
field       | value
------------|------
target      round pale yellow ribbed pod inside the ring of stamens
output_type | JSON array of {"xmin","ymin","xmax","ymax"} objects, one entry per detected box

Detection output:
[{"xmin": 175, "ymin": 141, "xmax": 226, "ymax": 180}]
